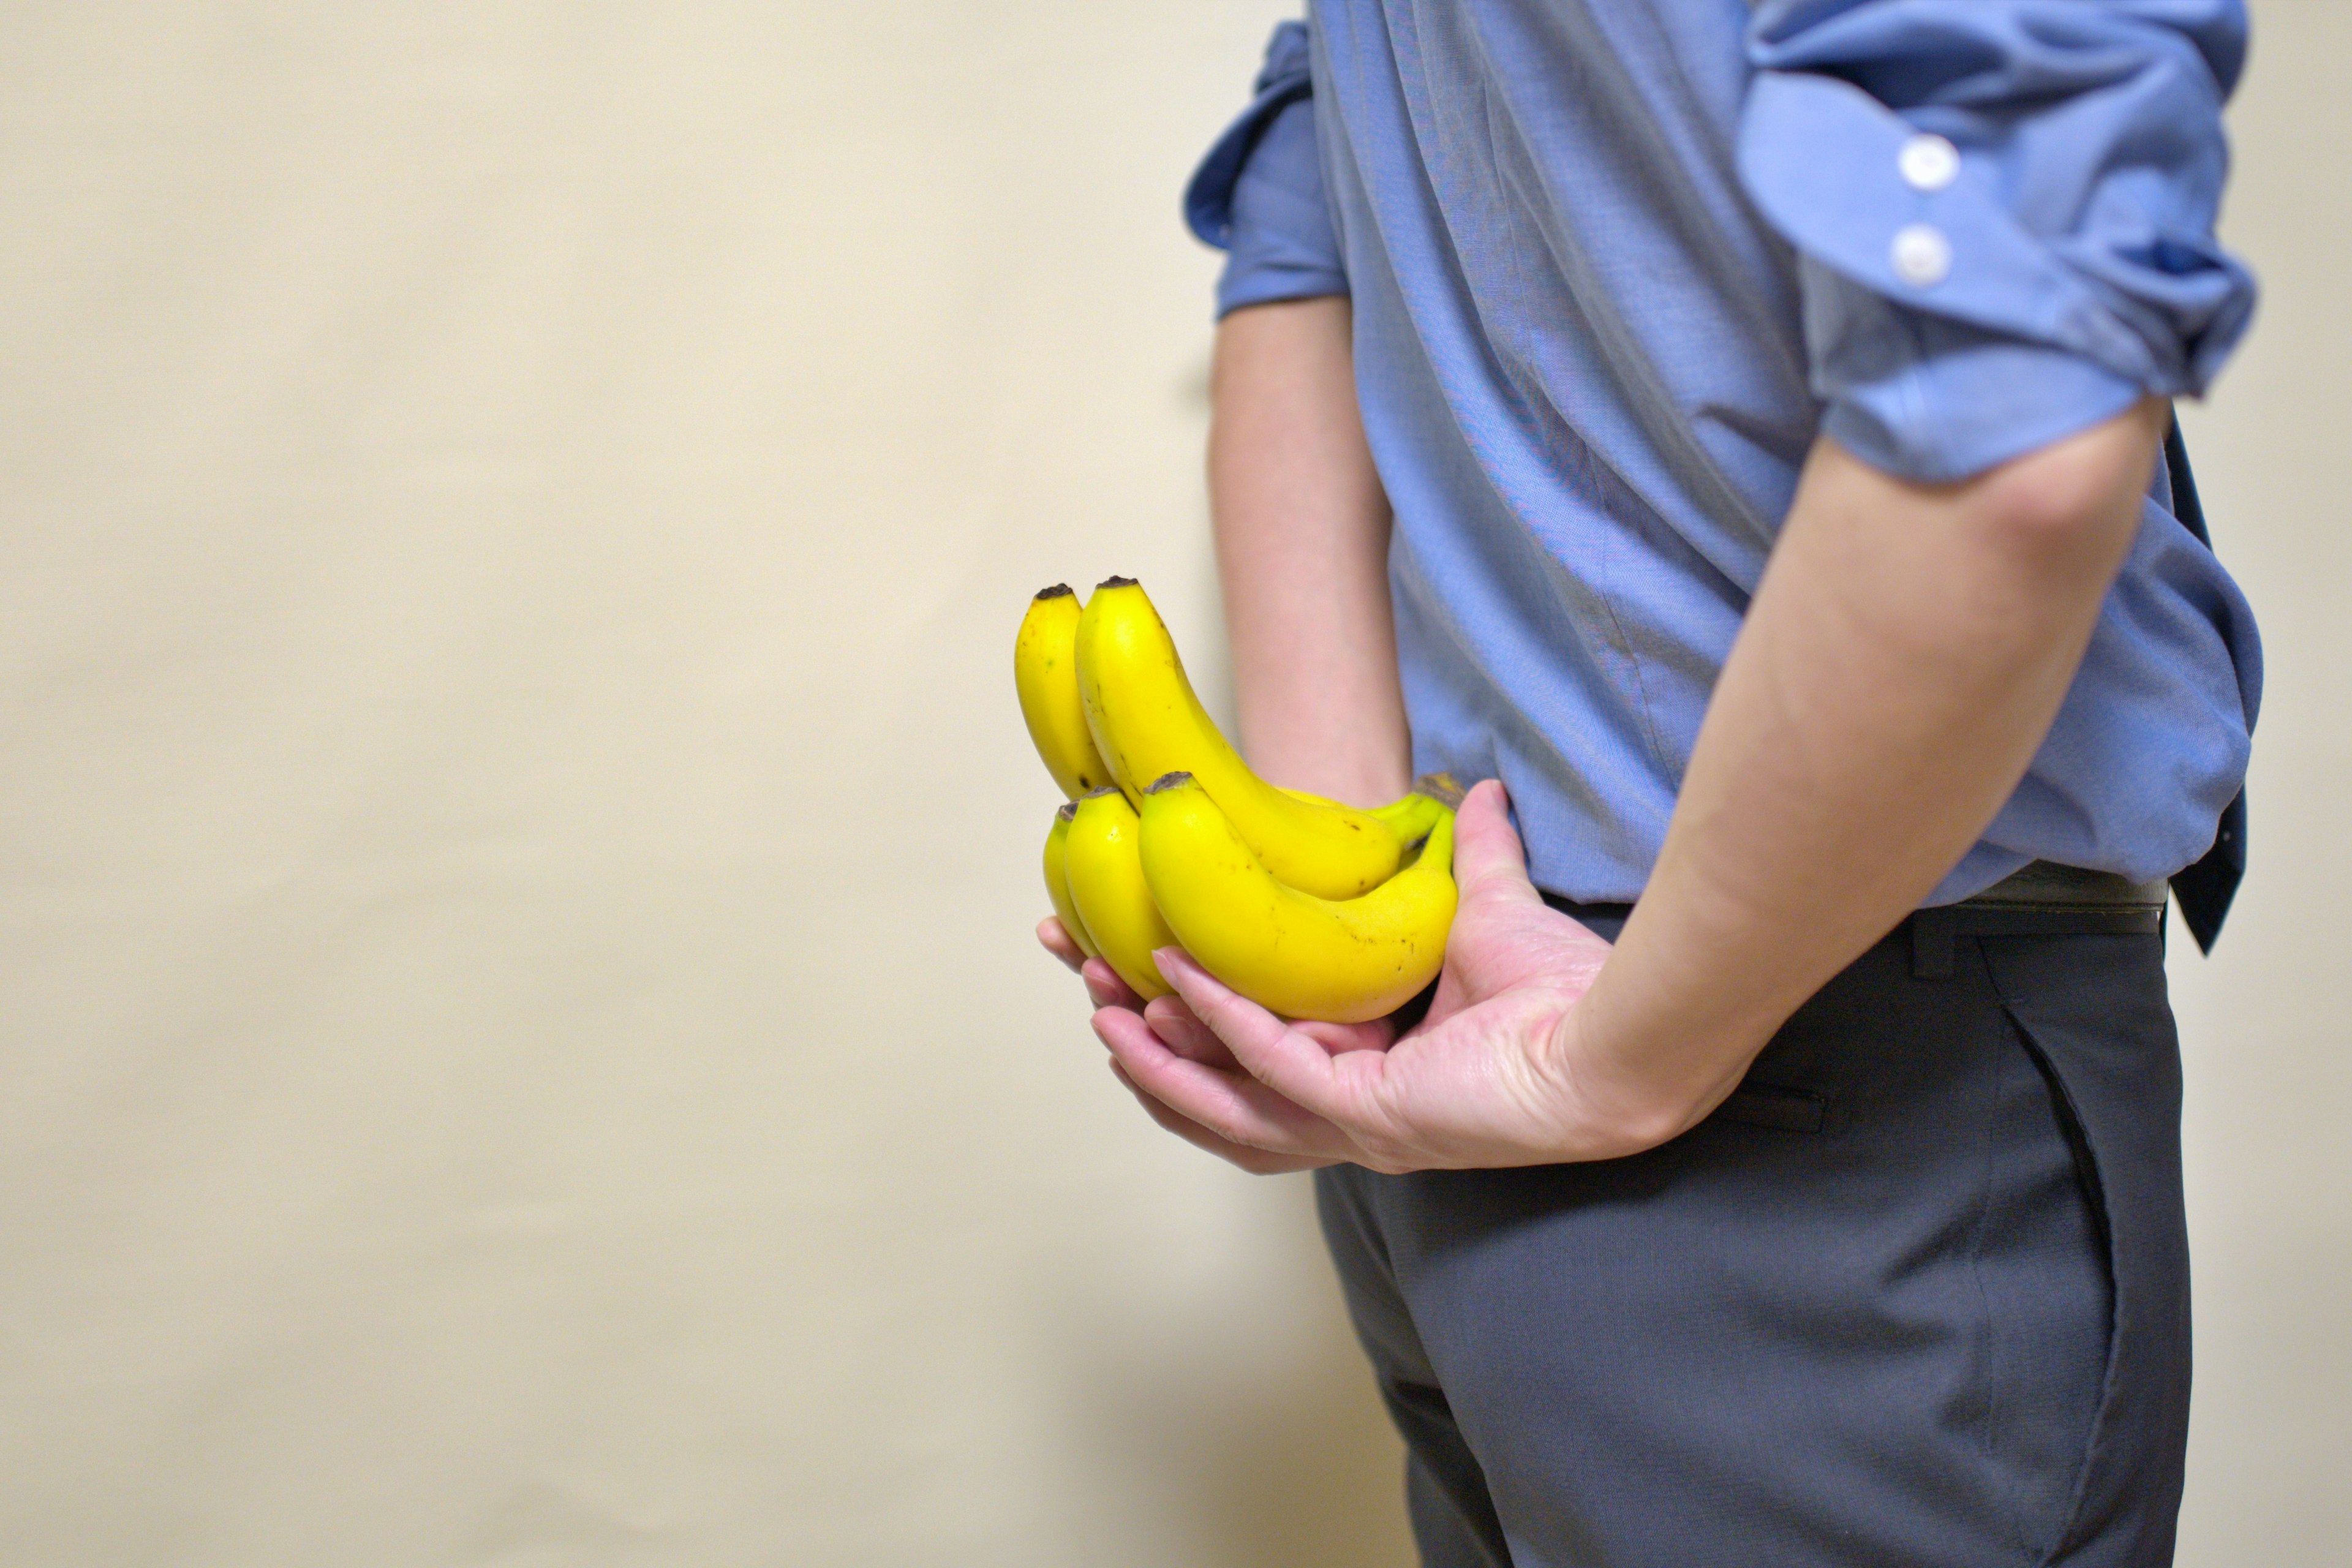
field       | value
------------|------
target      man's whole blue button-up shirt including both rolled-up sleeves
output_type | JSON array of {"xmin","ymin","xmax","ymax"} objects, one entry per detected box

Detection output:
[{"xmin": 1185, "ymin": 0, "xmax": 2260, "ymax": 903}]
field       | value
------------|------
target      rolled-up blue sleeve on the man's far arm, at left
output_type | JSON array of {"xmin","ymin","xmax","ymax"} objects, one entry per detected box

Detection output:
[{"xmin": 1183, "ymin": 21, "xmax": 1348, "ymax": 315}]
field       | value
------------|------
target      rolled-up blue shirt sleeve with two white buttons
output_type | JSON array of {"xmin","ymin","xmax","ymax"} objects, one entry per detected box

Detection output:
[{"xmin": 1738, "ymin": 0, "xmax": 2253, "ymax": 482}]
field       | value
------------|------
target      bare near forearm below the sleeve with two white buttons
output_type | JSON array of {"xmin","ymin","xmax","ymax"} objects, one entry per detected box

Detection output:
[{"xmin": 1576, "ymin": 404, "xmax": 2162, "ymax": 1114}]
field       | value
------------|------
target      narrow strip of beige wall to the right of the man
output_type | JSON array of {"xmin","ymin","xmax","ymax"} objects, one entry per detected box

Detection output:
[{"xmin": 2171, "ymin": 0, "xmax": 2352, "ymax": 1568}]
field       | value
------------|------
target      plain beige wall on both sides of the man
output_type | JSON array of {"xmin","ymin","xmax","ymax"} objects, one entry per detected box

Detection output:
[{"xmin": 0, "ymin": 0, "xmax": 2352, "ymax": 1568}]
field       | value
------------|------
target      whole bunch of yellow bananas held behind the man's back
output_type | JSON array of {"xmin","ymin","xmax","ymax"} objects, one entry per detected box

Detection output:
[{"xmin": 1014, "ymin": 578, "xmax": 1461, "ymax": 1023}]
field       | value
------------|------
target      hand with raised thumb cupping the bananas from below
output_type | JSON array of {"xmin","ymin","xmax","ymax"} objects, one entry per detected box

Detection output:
[{"xmin": 1094, "ymin": 780, "xmax": 1703, "ymax": 1170}]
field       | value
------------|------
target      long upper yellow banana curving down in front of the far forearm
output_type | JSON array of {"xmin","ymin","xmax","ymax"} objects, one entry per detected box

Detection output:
[{"xmin": 1077, "ymin": 576, "xmax": 1404, "ymax": 898}]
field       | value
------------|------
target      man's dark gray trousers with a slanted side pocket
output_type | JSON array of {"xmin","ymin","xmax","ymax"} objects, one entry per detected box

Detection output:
[{"xmin": 1317, "ymin": 919, "xmax": 2190, "ymax": 1568}]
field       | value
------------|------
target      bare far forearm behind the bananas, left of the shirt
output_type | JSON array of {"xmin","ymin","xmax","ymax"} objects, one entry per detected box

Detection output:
[{"xmin": 1209, "ymin": 298, "xmax": 1411, "ymax": 804}]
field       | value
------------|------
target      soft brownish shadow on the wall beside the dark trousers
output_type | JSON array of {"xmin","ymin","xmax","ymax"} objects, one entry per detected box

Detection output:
[{"xmin": 1061, "ymin": 1175, "xmax": 1419, "ymax": 1568}]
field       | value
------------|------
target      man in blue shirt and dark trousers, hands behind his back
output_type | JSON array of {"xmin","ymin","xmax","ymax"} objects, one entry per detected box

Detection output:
[{"xmin": 1042, "ymin": 0, "xmax": 2260, "ymax": 1568}]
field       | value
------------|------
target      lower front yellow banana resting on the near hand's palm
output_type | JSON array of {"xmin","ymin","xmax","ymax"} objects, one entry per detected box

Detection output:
[{"xmin": 1140, "ymin": 774, "xmax": 1456, "ymax": 1023}]
